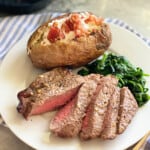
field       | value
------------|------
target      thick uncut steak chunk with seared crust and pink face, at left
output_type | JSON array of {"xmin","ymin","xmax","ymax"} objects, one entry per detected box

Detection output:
[{"xmin": 17, "ymin": 68, "xmax": 84, "ymax": 118}]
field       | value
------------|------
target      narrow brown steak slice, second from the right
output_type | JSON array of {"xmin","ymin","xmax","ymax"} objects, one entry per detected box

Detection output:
[{"xmin": 101, "ymin": 87, "xmax": 120, "ymax": 140}]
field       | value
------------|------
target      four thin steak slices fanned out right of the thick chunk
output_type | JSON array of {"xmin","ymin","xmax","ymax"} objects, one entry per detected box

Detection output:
[{"xmin": 47, "ymin": 71, "xmax": 138, "ymax": 140}]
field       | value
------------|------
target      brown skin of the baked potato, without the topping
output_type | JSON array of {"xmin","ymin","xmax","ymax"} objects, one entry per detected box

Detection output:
[{"xmin": 27, "ymin": 14, "xmax": 111, "ymax": 69}]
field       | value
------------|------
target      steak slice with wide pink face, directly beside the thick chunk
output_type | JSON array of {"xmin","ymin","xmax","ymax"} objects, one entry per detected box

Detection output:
[{"xmin": 50, "ymin": 75, "xmax": 100, "ymax": 137}]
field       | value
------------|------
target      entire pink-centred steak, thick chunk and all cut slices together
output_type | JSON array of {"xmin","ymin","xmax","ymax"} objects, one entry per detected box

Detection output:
[{"xmin": 17, "ymin": 68, "xmax": 138, "ymax": 140}]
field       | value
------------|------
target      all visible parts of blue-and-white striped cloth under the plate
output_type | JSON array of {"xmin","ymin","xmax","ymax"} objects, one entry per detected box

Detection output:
[{"xmin": 0, "ymin": 13, "xmax": 150, "ymax": 150}]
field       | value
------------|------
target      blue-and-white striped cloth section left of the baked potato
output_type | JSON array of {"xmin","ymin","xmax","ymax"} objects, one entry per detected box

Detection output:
[{"xmin": 0, "ymin": 13, "xmax": 58, "ymax": 59}]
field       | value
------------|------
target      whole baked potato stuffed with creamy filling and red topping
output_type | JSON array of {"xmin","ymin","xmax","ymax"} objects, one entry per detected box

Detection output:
[{"xmin": 27, "ymin": 12, "xmax": 111, "ymax": 69}]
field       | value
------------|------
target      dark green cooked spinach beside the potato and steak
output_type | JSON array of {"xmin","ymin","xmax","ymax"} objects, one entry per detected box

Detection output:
[{"xmin": 78, "ymin": 53, "xmax": 150, "ymax": 107}]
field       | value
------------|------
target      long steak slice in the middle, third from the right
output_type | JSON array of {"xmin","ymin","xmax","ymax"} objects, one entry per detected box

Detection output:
[{"xmin": 80, "ymin": 75, "xmax": 118, "ymax": 140}]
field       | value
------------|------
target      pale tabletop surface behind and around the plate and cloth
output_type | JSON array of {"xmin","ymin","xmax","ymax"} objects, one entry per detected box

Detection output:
[{"xmin": 0, "ymin": 0, "xmax": 150, "ymax": 150}]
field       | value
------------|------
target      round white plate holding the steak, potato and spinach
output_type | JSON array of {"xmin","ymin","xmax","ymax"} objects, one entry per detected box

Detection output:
[{"xmin": 0, "ymin": 25, "xmax": 150, "ymax": 150}]
